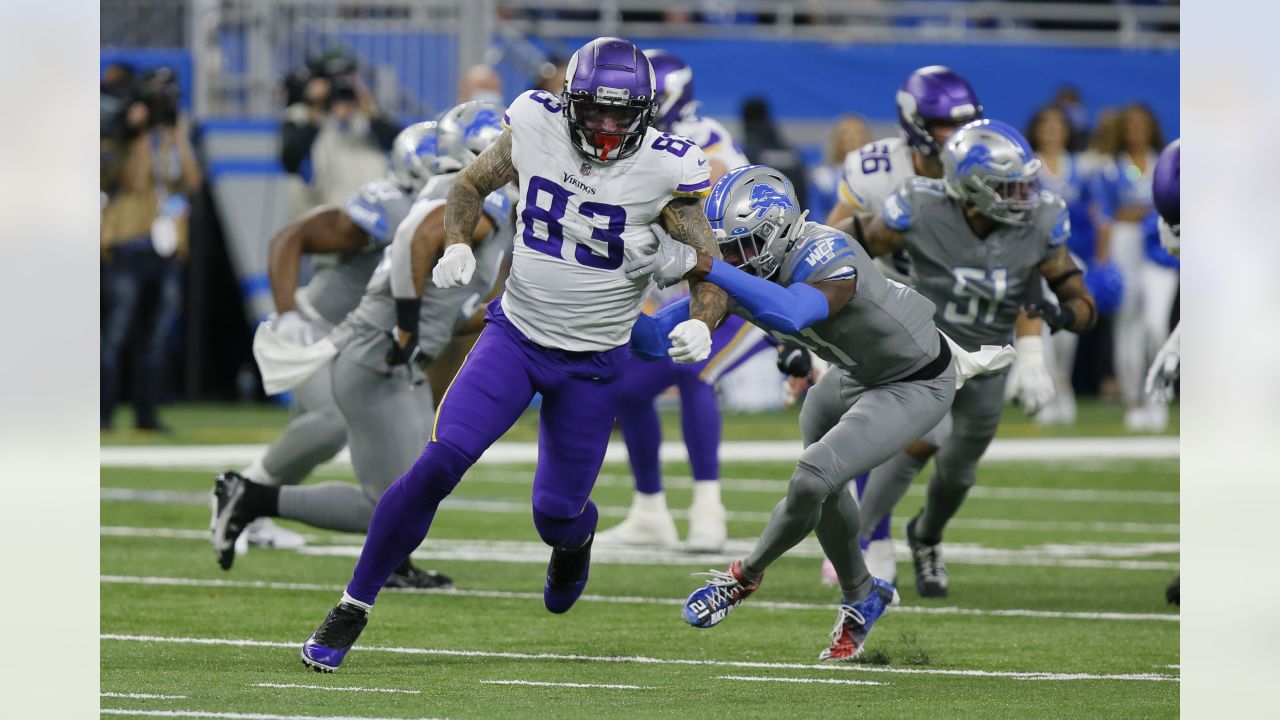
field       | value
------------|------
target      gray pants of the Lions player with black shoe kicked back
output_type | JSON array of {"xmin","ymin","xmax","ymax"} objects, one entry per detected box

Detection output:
[{"xmin": 279, "ymin": 350, "xmax": 435, "ymax": 533}]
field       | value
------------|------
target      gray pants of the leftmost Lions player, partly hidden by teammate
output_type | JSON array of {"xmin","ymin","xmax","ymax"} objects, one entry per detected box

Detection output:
[{"xmin": 253, "ymin": 364, "xmax": 347, "ymax": 486}]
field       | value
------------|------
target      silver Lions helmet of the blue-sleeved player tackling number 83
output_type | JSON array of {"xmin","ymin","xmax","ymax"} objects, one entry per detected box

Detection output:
[{"xmin": 705, "ymin": 165, "xmax": 808, "ymax": 278}]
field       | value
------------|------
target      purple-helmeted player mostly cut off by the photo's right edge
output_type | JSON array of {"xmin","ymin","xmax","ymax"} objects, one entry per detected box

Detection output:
[{"xmin": 1146, "ymin": 140, "xmax": 1183, "ymax": 605}]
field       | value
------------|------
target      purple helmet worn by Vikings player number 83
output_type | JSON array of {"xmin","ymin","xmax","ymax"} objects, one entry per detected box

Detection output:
[{"xmin": 562, "ymin": 37, "xmax": 657, "ymax": 161}]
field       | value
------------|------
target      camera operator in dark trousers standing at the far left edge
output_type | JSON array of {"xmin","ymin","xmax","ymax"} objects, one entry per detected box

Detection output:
[{"xmin": 99, "ymin": 68, "xmax": 201, "ymax": 430}]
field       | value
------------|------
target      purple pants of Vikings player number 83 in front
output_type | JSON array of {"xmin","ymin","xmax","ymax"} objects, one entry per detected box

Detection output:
[{"xmin": 347, "ymin": 297, "xmax": 630, "ymax": 603}]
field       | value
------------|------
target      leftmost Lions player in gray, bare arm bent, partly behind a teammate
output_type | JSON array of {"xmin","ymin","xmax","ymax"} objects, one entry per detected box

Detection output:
[{"xmin": 241, "ymin": 122, "xmax": 436, "ymax": 547}]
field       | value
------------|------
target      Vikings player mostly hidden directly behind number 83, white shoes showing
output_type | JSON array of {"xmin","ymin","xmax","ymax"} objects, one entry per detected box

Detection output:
[{"xmin": 595, "ymin": 50, "xmax": 773, "ymax": 552}]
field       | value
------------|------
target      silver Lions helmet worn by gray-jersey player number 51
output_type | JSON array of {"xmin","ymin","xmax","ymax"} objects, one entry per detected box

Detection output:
[{"xmin": 942, "ymin": 119, "xmax": 1041, "ymax": 225}]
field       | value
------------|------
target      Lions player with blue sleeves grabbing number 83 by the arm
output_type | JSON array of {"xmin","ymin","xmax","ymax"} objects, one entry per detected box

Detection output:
[{"xmin": 628, "ymin": 165, "xmax": 956, "ymax": 661}]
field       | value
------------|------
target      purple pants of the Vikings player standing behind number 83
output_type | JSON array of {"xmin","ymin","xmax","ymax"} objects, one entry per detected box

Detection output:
[{"xmin": 618, "ymin": 315, "xmax": 772, "ymax": 495}]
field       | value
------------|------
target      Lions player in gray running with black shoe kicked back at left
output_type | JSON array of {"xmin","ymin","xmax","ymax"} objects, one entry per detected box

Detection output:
[{"xmin": 215, "ymin": 102, "xmax": 512, "ymax": 587}]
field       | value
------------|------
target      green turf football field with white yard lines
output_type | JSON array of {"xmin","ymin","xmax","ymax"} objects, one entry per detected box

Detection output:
[{"xmin": 101, "ymin": 405, "xmax": 1179, "ymax": 719}]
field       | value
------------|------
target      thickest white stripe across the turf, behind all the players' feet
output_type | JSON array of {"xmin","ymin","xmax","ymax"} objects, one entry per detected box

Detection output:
[{"xmin": 99, "ymin": 437, "xmax": 1179, "ymax": 469}]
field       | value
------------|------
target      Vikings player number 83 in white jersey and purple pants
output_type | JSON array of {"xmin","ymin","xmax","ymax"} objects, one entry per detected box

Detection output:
[{"xmin": 293, "ymin": 37, "xmax": 728, "ymax": 671}]
